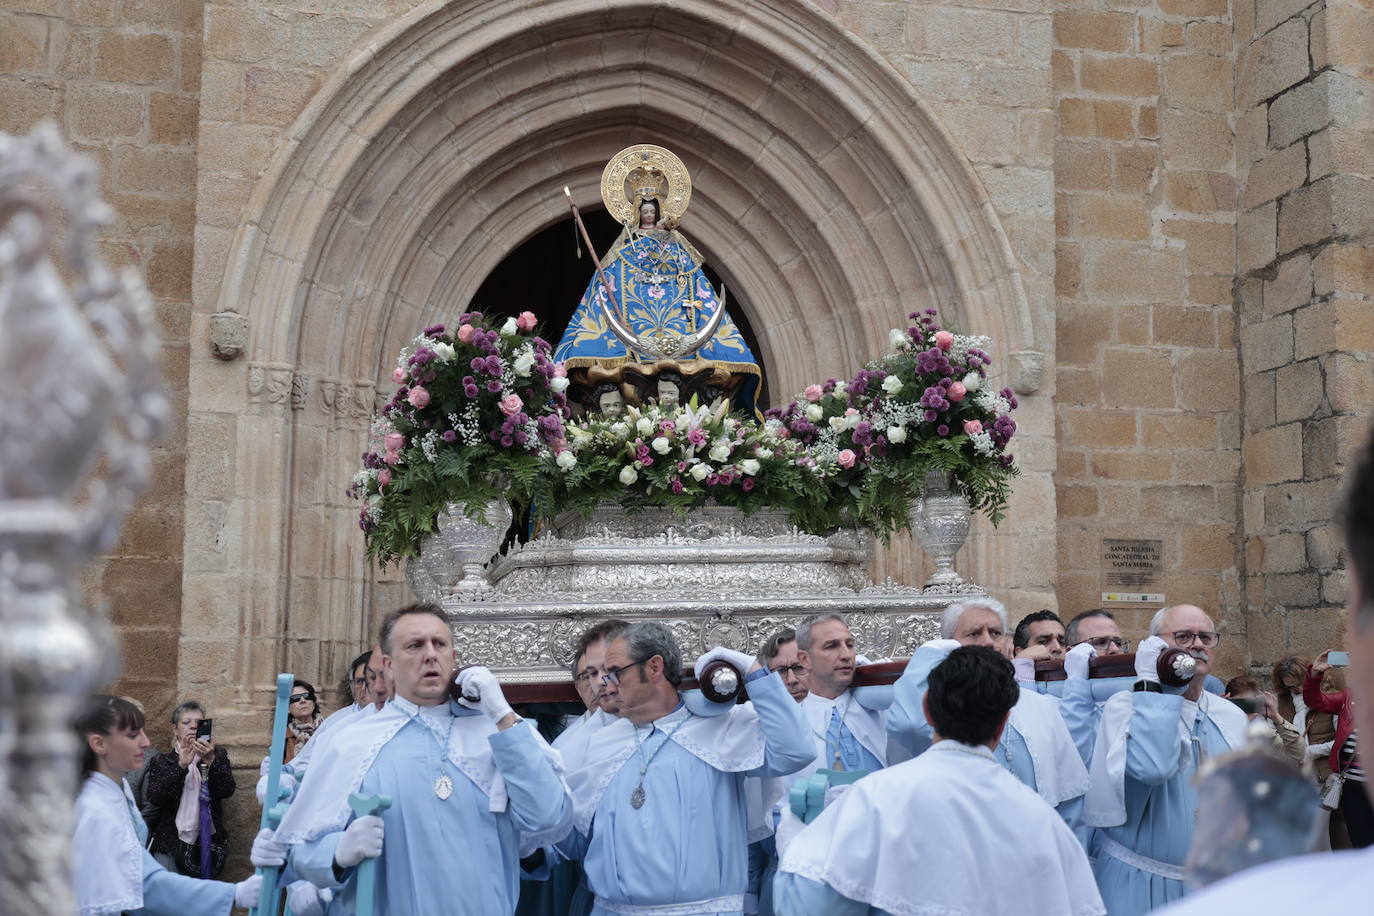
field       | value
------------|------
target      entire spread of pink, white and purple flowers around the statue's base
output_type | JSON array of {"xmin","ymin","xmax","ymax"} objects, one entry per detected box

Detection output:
[{"xmin": 350, "ymin": 309, "xmax": 1017, "ymax": 563}]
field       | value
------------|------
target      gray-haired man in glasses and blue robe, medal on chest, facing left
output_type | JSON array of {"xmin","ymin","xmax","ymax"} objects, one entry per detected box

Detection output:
[{"xmin": 555, "ymin": 622, "xmax": 813, "ymax": 916}]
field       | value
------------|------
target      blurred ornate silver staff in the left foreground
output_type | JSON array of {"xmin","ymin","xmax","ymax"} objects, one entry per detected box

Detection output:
[{"xmin": 0, "ymin": 125, "xmax": 166, "ymax": 916}]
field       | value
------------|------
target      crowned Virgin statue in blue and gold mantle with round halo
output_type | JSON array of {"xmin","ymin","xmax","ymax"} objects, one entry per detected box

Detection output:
[{"xmin": 555, "ymin": 144, "xmax": 761, "ymax": 412}]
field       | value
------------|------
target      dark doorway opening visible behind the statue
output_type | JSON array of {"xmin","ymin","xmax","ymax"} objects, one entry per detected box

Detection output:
[{"xmin": 470, "ymin": 207, "xmax": 768, "ymax": 409}]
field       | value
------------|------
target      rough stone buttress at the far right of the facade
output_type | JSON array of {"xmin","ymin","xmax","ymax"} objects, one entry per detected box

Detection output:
[{"xmin": 1235, "ymin": 0, "xmax": 1374, "ymax": 667}]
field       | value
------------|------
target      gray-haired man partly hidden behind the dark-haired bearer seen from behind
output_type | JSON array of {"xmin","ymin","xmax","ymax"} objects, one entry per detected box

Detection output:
[{"xmin": 888, "ymin": 596, "xmax": 1088, "ymax": 840}]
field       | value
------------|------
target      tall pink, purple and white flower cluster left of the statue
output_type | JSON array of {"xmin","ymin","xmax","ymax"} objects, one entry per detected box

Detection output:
[{"xmin": 350, "ymin": 312, "xmax": 569, "ymax": 563}]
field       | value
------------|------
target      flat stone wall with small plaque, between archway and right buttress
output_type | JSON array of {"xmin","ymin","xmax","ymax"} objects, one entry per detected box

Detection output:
[{"xmin": 1054, "ymin": 0, "xmax": 1245, "ymax": 665}]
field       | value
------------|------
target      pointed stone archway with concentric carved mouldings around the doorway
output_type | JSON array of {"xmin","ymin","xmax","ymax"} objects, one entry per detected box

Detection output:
[{"xmin": 183, "ymin": 0, "xmax": 1054, "ymax": 706}]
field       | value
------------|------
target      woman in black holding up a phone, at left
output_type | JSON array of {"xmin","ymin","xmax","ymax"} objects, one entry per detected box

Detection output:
[{"xmin": 144, "ymin": 700, "xmax": 235, "ymax": 878}]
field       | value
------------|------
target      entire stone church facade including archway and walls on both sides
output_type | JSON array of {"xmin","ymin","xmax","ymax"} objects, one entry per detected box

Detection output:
[{"xmin": 0, "ymin": 0, "xmax": 1374, "ymax": 836}]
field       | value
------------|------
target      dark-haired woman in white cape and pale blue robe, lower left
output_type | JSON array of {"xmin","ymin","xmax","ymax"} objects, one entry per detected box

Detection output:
[{"xmin": 73, "ymin": 694, "xmax": 261, "ymax": 916}]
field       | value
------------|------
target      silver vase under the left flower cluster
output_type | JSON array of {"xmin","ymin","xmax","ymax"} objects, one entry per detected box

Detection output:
[{"xmin": 405, "ymin": 499, "xmax": 514, "ymax": 600}]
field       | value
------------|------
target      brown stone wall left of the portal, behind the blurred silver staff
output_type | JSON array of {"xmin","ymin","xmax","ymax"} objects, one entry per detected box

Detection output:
[{"xmin": 0, "ymin": 0, "xmax": 201, "ymax": 743}]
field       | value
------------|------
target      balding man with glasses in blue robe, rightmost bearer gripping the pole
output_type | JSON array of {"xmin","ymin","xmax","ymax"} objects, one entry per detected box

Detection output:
[{"xmin": 1084, "ymin": 604, "xmax": 1246, "ymax": 916}]
